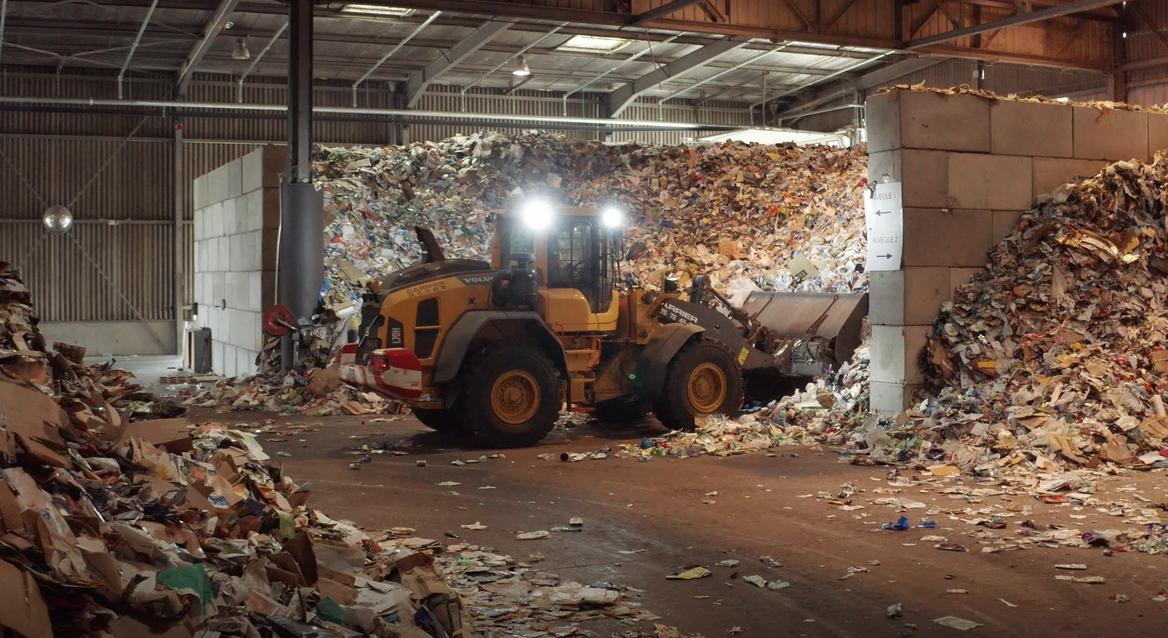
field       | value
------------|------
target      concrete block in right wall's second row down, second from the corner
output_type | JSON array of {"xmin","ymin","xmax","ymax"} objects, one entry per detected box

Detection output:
[{"xmin": 948, "ymin": 153, "xmax": 1034, "ymax": 210}]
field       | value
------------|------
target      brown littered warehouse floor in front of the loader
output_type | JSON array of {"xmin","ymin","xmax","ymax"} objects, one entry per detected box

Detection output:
[{"xmin": 192, "ymin": 410, "xmax": 1168, "ymax": 638}]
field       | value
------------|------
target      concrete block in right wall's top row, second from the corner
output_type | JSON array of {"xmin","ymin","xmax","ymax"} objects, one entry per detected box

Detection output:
[{"xmin": 989, "ymin": 99, "xmax": 1075, "ymax": 158}]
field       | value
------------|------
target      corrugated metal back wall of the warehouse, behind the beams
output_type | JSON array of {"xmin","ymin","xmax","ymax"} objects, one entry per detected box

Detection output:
[{"xmin": 0, "ymin": 72, "xmax": 749, "ymax": 338}]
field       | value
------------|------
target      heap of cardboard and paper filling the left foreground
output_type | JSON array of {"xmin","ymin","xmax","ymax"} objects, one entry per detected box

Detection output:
[{"xmin": 0, "ymin": 262, "xmax": 656, "ymax": 638}]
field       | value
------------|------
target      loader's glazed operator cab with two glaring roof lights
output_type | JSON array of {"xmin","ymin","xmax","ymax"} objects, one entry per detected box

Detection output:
[{"xmin": 494, "ymin": 201, "xmax": 623, "ymax": 333}]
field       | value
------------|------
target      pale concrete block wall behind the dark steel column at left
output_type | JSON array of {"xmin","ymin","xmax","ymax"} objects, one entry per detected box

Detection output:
[{"xmin": 194, "ymin": 146, "xmax": 287, "ymax": 376}]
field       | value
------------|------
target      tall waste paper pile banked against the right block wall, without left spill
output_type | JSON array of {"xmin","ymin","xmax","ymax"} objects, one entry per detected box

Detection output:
[{"xmin": 910, "ymin": 157, "xmax": 1168, "ymax": 469}]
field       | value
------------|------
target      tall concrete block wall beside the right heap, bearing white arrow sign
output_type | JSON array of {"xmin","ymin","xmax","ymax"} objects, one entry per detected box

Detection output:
[{"xmin": 868, "ymin": 91, "xmax": 1168, "ymax": 412}]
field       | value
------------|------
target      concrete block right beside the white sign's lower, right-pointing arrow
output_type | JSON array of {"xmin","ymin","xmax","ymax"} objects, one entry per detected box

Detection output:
[{"xmin": 904, "ymin": 208, "xmax": 997, "ymax": 266}]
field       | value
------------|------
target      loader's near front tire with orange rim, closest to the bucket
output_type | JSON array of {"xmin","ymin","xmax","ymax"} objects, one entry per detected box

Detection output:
[{"xmin": 653, "ymin": 337, "xmax": 743, "ymax": 431}]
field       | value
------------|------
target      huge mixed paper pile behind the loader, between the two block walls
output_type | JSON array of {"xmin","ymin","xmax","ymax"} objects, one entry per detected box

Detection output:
[{"xmin": 314, "ymin": 132, "xmax": 868, "ymax": 314}]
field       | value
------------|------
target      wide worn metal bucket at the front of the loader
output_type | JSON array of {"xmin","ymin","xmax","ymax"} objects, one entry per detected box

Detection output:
[{"xmin": 743, "ymin": 291, "xmax": 868, "ymax": 365}]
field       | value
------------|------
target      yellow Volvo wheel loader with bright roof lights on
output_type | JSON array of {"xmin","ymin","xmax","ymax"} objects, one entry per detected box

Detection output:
[{"xmin": 340, "ymin": 201, "xmax": 867, "ymax": 448}]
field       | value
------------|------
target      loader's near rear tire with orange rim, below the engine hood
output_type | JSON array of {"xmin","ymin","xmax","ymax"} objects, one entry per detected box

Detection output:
[{"xmin": 453, "ymin": 341, "xmax": 561, "ymax": 448}]
